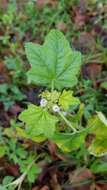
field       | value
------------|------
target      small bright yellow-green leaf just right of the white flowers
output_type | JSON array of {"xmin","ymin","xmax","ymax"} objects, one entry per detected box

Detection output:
[{"xmin": 59, "ymin": 90, "xmax": 80, "ymax": 110}]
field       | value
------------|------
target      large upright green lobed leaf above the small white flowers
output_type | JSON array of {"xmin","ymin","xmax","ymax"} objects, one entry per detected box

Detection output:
[{"xmin": 25, "ymin": 30, "xmax": 81, "ymax": 89}]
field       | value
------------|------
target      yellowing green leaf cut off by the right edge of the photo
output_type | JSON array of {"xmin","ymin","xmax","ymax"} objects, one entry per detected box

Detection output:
[{"xmin": 88, "ymin": 112, "xmax": 107, "ymax": 156}]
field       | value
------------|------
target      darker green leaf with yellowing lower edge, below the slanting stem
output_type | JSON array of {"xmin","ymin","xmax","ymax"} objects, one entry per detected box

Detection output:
[{"xmin": 52, "ymin": 130, "xmax": 87, "ymax": 152}]
